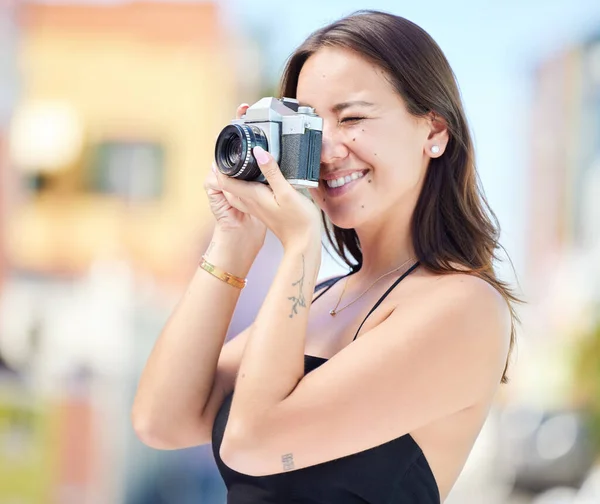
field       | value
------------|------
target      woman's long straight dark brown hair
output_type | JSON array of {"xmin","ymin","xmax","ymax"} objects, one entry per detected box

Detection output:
[{"xmin": 281, "ymin": 10, "xmax": 520, "ymax": 383}]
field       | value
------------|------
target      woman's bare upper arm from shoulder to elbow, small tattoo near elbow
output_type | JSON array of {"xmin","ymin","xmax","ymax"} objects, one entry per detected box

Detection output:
[{"xmin": 221, "ymin": 274, "xmax": 510, "ymax": 476}]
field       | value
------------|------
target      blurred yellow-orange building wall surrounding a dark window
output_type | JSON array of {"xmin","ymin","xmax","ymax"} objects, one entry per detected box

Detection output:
[{"xmin": 7, "ymin": 2, "xmax": 246, "ymax": 280}]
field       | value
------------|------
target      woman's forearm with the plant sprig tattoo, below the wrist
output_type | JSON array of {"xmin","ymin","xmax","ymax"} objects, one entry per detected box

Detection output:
[{"xmin": 228, "ymin": 239, "xmax": 321, "ymax": 431}]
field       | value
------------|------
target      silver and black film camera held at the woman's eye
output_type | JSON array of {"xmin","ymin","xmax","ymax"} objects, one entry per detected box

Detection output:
[{"xmin": 215, "ymin": 97, "xmax": 323, "ymax": 189}]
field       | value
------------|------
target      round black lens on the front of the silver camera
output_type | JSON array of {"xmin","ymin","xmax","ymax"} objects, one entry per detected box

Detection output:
[{"xmin": 215, "ymin": 124, "xmax": 268, "ymax": 180}]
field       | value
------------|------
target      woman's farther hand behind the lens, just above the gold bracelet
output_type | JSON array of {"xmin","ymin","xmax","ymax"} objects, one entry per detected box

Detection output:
[{"xmin": 204, "ymin": 104, "xmax": 267, "ymax": 248}]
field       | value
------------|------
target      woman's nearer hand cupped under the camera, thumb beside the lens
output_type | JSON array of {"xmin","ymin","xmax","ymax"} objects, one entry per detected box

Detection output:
[{"xmin": 217, "ymin": 147, "xmax": 321, "ymax": 250}]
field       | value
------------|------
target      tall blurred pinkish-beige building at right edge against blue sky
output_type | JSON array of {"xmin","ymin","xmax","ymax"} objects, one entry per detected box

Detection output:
[{"xmin": 527, "ymin": 37, "xmax": 600, "ymax": 304}]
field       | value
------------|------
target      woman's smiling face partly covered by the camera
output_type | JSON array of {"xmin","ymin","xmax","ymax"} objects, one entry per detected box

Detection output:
[{"xmin": 297, "ymin": 48, "xmax": 430, "ymax": 228}]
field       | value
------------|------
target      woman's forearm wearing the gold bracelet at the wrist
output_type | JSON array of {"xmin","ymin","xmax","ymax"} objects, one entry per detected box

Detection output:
[{"xmin": 132, "ymin": 228, "xmax": 258, "ymax": 436}]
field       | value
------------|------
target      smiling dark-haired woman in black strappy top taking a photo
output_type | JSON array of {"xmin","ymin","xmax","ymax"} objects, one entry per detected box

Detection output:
[{"xmin": 133, "ymin": 11, "xmax": 516, "ymax": 504}]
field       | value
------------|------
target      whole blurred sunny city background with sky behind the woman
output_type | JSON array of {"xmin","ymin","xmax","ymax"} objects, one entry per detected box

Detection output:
[{"xmin": 0, "ymin": 0, "xmax": 600, "ymax": 504}]
